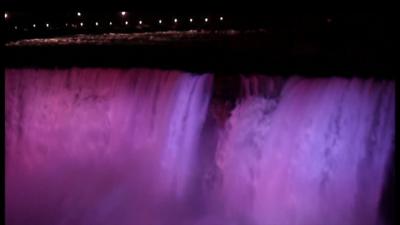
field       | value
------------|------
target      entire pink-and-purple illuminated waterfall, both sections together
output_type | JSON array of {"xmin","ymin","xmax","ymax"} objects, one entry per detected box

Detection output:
[{"xmin": 5, "ymin": 69, "xmax": 395, "ymax": 225}]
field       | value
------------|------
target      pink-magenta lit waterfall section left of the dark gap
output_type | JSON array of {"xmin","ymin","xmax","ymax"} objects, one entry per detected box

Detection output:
[{"xmin": 5, "ymin": 69, "xmax": 212, "ymax": 225}]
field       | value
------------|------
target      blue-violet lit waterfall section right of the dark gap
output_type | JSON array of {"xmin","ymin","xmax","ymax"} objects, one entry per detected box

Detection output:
[{"xmin": 217, "ymin": 76, "xmax": 395, "ymax": 225}]
